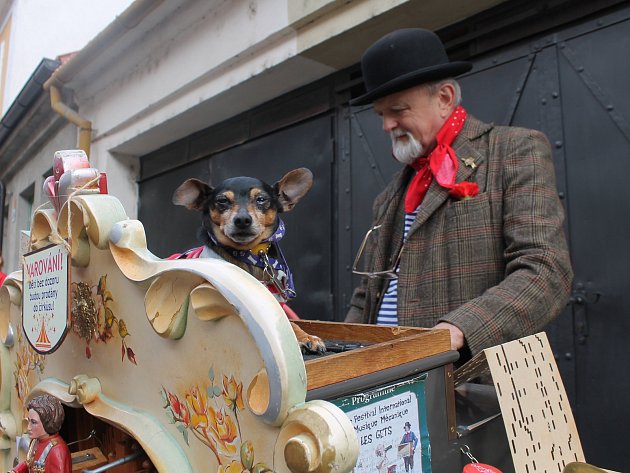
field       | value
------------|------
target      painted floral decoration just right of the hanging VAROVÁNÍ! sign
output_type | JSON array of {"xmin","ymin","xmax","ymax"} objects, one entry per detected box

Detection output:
[{"xmin": 70, "ymin": 274, "xmax": 137, "ymax": 365}]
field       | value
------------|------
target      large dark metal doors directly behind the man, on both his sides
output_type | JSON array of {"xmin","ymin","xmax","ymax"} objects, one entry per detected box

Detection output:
[{"xmin": 340, "ymin": 8, "xmax": 630, "ymax": 471}]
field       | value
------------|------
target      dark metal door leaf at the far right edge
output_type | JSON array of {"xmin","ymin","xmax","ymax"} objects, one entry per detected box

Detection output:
[{"xmin": 557, "ymin": 9, "xmax": 630, "ymax": 471}]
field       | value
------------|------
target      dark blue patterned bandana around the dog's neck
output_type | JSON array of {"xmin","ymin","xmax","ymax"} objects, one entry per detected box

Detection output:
[{"xmin": 208, "ymin": 219, "xmax": 296, "ymax": 300}]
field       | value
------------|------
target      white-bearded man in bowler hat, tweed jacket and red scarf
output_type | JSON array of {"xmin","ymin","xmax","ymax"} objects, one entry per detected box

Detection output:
[{"xmin": 346, "ymin": 29, "xmax": 573, "ymax": 361}]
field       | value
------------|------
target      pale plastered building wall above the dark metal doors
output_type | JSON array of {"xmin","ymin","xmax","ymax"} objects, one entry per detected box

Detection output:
[{"xmin": 65, "ymin": 0, "xmax": 501, "ymax": 216}]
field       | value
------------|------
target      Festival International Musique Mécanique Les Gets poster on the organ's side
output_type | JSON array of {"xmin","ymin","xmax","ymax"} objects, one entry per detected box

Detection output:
[{"xmin": 333, "ymin": 375, "xmax": 431, "ymax": 473}]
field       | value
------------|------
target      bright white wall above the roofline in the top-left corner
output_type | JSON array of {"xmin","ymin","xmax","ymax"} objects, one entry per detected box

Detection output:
[{"xmin": 1, "ymin": 0, "xmax": 133, "ymax": 115}]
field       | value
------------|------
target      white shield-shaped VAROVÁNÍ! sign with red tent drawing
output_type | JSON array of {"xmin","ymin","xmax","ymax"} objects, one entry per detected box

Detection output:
[{"xmin": 22, "ymin": 245, "xmax": 70, "ymax": 354}]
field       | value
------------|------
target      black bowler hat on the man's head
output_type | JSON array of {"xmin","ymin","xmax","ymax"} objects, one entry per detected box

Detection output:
[{"xmin": 350, "ymin": 28, "xmax": 472, "ymax": 105}]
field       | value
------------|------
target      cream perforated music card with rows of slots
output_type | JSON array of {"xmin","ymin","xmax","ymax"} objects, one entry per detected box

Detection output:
[{"xmin": 484, "ymin": 332, "xmax": 584, "ymax": 473}]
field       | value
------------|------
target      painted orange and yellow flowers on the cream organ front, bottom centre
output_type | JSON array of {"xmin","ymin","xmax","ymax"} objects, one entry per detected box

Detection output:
[{"xmin": 160, "ymin": 368, "xmax": 273, "ymax": 473}]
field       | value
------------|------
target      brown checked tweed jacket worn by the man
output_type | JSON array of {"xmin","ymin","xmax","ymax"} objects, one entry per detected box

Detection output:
[{"xmin": 346, "ymin": 115, "xmax": 573, "ymax": 355}]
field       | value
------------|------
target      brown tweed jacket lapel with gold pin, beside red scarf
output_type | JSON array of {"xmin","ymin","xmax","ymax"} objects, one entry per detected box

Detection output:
[{"xmin": 409, "ymin": 115, "xmax": 493, "ymax": 235}]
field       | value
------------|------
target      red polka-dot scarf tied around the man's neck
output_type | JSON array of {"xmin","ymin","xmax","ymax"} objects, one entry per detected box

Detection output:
[{"xmin": 405, "ymin": 106, "xmax": 467, "ymax": 213}]
